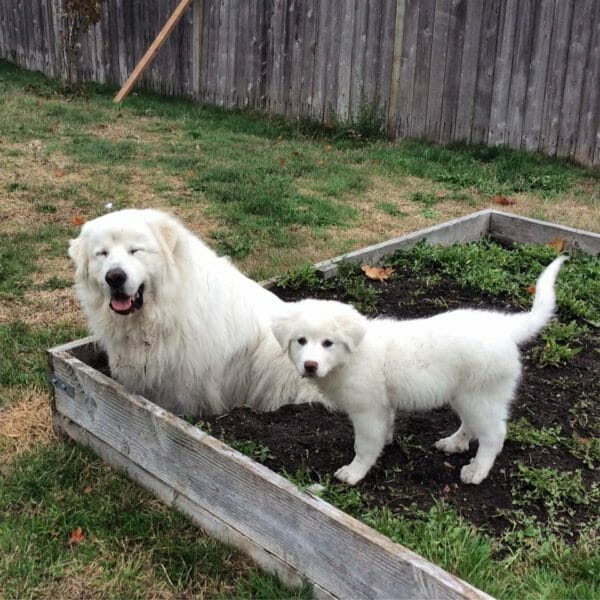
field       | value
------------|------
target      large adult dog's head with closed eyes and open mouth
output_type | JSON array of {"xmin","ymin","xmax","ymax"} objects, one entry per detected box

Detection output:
[{"xmin": 69, "ymin": 209, "xmax": 181, "ymax": 316}]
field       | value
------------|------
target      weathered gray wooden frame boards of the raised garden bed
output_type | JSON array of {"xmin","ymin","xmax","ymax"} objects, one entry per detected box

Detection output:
[{"xmin": 49, "ymin": 211, "xmax": 600, "ymax": 598}]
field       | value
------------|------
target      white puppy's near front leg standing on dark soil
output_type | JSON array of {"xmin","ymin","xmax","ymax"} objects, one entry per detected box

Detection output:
[{"xmin": 335, "ymin": 410, "xmax": 389, "ymax": 485}]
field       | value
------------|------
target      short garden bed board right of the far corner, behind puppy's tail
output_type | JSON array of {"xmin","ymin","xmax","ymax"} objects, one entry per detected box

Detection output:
[{"xmin": 489, "ymin": 211, "xmax": 600, "ymax": 256}]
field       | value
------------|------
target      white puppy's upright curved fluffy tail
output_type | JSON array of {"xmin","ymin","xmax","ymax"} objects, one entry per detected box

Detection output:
[{"xmin": 512, "ymin": 255, "xmax": 568, "ymax": 344}]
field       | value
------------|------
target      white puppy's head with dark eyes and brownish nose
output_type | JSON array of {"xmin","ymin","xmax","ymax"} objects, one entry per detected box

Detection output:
[{"xmin": 272, "ymin": 300, "xmax": 367, "ymax": 378}]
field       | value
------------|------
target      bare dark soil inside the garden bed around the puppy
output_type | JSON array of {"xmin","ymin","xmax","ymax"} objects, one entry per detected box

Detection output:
[{"xmin": 204, "ymin": 262, "xmax": 600, "ymax": 537}]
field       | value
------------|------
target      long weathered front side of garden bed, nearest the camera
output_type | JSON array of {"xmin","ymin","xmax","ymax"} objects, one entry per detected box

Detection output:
[{"xmin": 52, "ymin": 352, "xmax": 487, "ymax": 598}]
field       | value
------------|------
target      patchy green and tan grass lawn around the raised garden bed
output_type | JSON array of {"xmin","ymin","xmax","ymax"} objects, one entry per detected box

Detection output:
[{"xmin": 0, "ymin": 57, "xmax": 600, "ymax": 598}]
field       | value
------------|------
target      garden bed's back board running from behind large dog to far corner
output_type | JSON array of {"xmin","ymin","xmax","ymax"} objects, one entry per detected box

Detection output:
[{"xmin": 315, "ymin": 210, "xmax": 492, "ymax": 279}]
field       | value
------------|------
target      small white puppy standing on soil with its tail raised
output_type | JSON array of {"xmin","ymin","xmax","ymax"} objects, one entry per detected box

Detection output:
[{"xmin": 273, "ymin": 256, "xmax": 566, "ymax": 484}]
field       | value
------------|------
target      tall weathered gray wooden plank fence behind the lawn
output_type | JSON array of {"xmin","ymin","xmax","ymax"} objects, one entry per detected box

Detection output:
[{"xmin": 0, "ymin": 0, "xmax": 600, "ymax": 165}]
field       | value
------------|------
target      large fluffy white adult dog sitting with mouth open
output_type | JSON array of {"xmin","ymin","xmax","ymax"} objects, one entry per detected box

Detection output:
[{"xmin": 69, "ymin": 209, "xmax": 318, "ymax": 416}]
